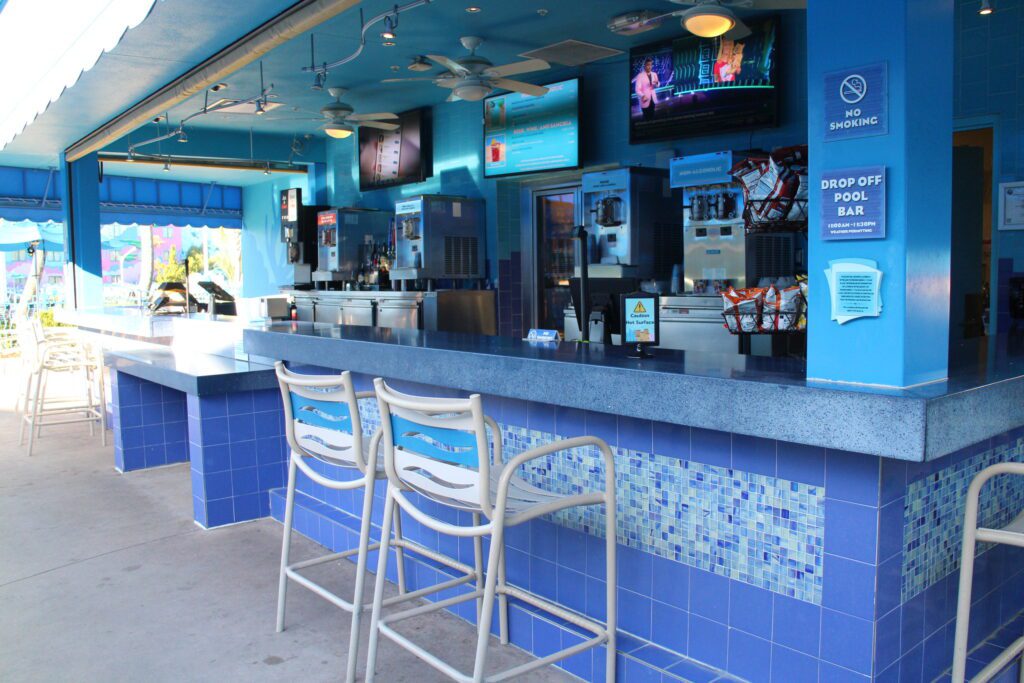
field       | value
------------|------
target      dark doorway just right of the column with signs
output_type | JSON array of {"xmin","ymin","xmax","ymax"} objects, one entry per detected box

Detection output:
[{"xmin": 949, "ymin": 127, "xmax": 993, "ymax": 354}]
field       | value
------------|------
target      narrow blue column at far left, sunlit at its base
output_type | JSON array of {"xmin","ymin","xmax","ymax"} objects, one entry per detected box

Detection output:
[{"xmin": 60, "ymin": 154, "xmax": 103, "ymax": 308}]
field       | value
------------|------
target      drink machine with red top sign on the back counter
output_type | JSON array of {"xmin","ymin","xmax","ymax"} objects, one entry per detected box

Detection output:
[{"xmin": 313, "ymin": 207, "xmax": 391, "ymax": 285}]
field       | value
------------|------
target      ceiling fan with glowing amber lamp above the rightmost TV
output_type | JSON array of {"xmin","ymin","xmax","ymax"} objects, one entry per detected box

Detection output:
[{"xmin": 608, "ymin": 0, "xmax": 807, "ymax": 40}]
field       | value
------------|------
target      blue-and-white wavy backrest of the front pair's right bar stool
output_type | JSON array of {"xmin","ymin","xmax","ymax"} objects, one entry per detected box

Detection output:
[{"xmin": 374, "ymin": 379, "xmax": 492, "ymax": 518}]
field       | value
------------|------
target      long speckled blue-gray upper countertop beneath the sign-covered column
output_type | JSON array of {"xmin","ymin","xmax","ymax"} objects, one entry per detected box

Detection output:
[{"xmin": 243, "ymin": 323, "xmax": 1024, "ymax": 461}]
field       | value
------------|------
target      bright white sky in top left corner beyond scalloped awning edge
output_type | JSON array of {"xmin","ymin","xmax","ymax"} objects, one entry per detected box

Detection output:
[{"xmin": 0, "ymin": 0, "xmax": 156, "ymax": 150}]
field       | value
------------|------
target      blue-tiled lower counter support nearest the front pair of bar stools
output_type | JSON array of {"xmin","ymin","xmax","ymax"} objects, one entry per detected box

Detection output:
[{"xmin": 186, "ymin": 389, "xmax": 288, "ymax": 528}]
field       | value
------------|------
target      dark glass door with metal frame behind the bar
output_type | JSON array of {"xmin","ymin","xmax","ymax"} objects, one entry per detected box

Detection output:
[{"xmin": 532, "ymin": 185, "xmax": 583, "ymax": 332}]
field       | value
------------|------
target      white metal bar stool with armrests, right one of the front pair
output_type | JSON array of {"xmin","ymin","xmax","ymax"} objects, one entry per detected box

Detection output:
[{"xmin": 366, "ymin": 379, "xmax": 617, "ymax": 683}]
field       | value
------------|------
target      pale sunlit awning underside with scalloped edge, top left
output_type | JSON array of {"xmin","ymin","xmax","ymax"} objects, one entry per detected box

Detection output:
[{"xmin": 0, "ymin": 0, "xmax": 295, "ymax": 168}]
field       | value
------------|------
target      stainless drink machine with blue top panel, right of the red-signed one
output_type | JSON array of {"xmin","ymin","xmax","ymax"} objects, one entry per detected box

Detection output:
[{"xmin": 390, "ymin": 195, "xmax": 486, "ymax": 281}]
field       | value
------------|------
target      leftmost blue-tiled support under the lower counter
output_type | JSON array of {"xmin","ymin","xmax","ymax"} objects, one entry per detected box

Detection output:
[{"xmin": 111, "ymin": 370, "xmax": 188, "ymax": 472}]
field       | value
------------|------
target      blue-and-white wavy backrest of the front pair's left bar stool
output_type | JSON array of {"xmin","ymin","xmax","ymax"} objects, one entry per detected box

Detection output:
[{"xmin": 274, "ymin": 360, "xmax": 367, "ymax": 472}]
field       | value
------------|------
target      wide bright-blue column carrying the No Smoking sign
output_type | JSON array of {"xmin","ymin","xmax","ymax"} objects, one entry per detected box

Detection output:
[{"xmin": 807, "ymin": 0, "xmax": 954, "ymax": 387}]
